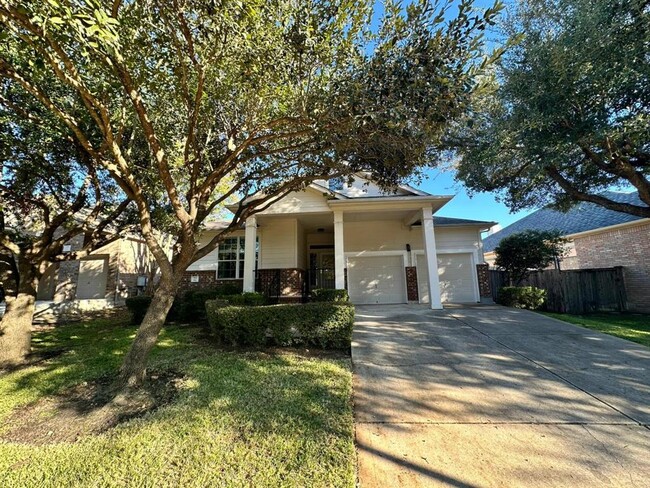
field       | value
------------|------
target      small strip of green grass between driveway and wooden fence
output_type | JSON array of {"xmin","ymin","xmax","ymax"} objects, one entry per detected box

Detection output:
[{"xmin": 544, "ymin": 312, "xmax": 650, "ymax": 347}]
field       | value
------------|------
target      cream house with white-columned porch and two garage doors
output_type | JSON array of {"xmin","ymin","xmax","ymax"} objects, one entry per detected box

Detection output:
[{"xmin": 183, "ymin": 174, "xmax": 494, "ymax": 308}]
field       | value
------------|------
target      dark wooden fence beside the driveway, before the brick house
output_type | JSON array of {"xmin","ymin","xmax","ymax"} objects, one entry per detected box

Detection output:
[{"xmin": 490, "ymin": 266, "xmax": 627, "ymax": 314}]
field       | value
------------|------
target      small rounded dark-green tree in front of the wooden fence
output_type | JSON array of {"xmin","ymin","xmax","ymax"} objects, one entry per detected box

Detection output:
[{"xmin": 494, "ymin": 230, "xmax": 566, "ymax": 285}]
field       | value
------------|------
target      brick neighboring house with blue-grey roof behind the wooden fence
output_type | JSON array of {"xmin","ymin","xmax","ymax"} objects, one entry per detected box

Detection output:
[{"xmin": 483, "ymin": 192, "xmax": 650, "ymax": 312}]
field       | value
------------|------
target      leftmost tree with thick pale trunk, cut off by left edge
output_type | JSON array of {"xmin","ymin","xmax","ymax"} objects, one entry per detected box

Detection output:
[{"xmin": 0, "ymin": 85, "xmax": 129, "ymax": 367}]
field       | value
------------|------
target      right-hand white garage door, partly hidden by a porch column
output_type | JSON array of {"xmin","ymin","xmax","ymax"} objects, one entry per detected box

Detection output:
[{"xmin": 417, "ymin": 253, "xmax": 476, "ymax": 303}]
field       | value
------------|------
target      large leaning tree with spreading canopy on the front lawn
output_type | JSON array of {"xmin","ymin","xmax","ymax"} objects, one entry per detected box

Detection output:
[{"xmin": 0, "ymin": 0, "xmax": 501, "ymax": 387}]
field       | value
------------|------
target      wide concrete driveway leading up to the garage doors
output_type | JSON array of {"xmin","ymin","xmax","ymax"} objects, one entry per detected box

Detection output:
[{"xmin": 352, "ymin": 305, "xmax": 650, "ymax": 488}]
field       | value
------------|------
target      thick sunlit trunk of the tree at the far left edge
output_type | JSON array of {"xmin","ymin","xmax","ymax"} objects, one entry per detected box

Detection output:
[{"xmin": 0, "ymin": 266, "xmax": 38, "ymax": 367}]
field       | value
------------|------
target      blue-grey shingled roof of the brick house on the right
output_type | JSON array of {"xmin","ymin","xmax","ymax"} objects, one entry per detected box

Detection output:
[{"xmin": 483, "ymin": 191, "xmax": 645, "ymax": 252}]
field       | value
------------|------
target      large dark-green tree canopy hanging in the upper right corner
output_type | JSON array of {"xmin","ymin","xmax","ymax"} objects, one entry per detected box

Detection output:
[{"xmin": 454, "ymin": 0, "xmax": 650, "ymax": 217}]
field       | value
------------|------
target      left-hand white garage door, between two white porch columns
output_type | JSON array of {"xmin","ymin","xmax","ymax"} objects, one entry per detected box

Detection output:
[{"xmin": 348, "ymin": 256, "xmax": 406, "ymax": 304}]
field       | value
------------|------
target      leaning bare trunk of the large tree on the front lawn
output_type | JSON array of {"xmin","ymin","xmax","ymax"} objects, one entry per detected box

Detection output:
[{"xmin": 117, "ymin": 276, "xmax": 180, "ymax": 389}]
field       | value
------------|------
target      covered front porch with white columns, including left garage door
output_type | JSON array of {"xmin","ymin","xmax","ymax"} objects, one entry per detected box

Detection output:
[{"xmin": 243, "ymin": 201, "xmax": 442, "ymax": 309}]
